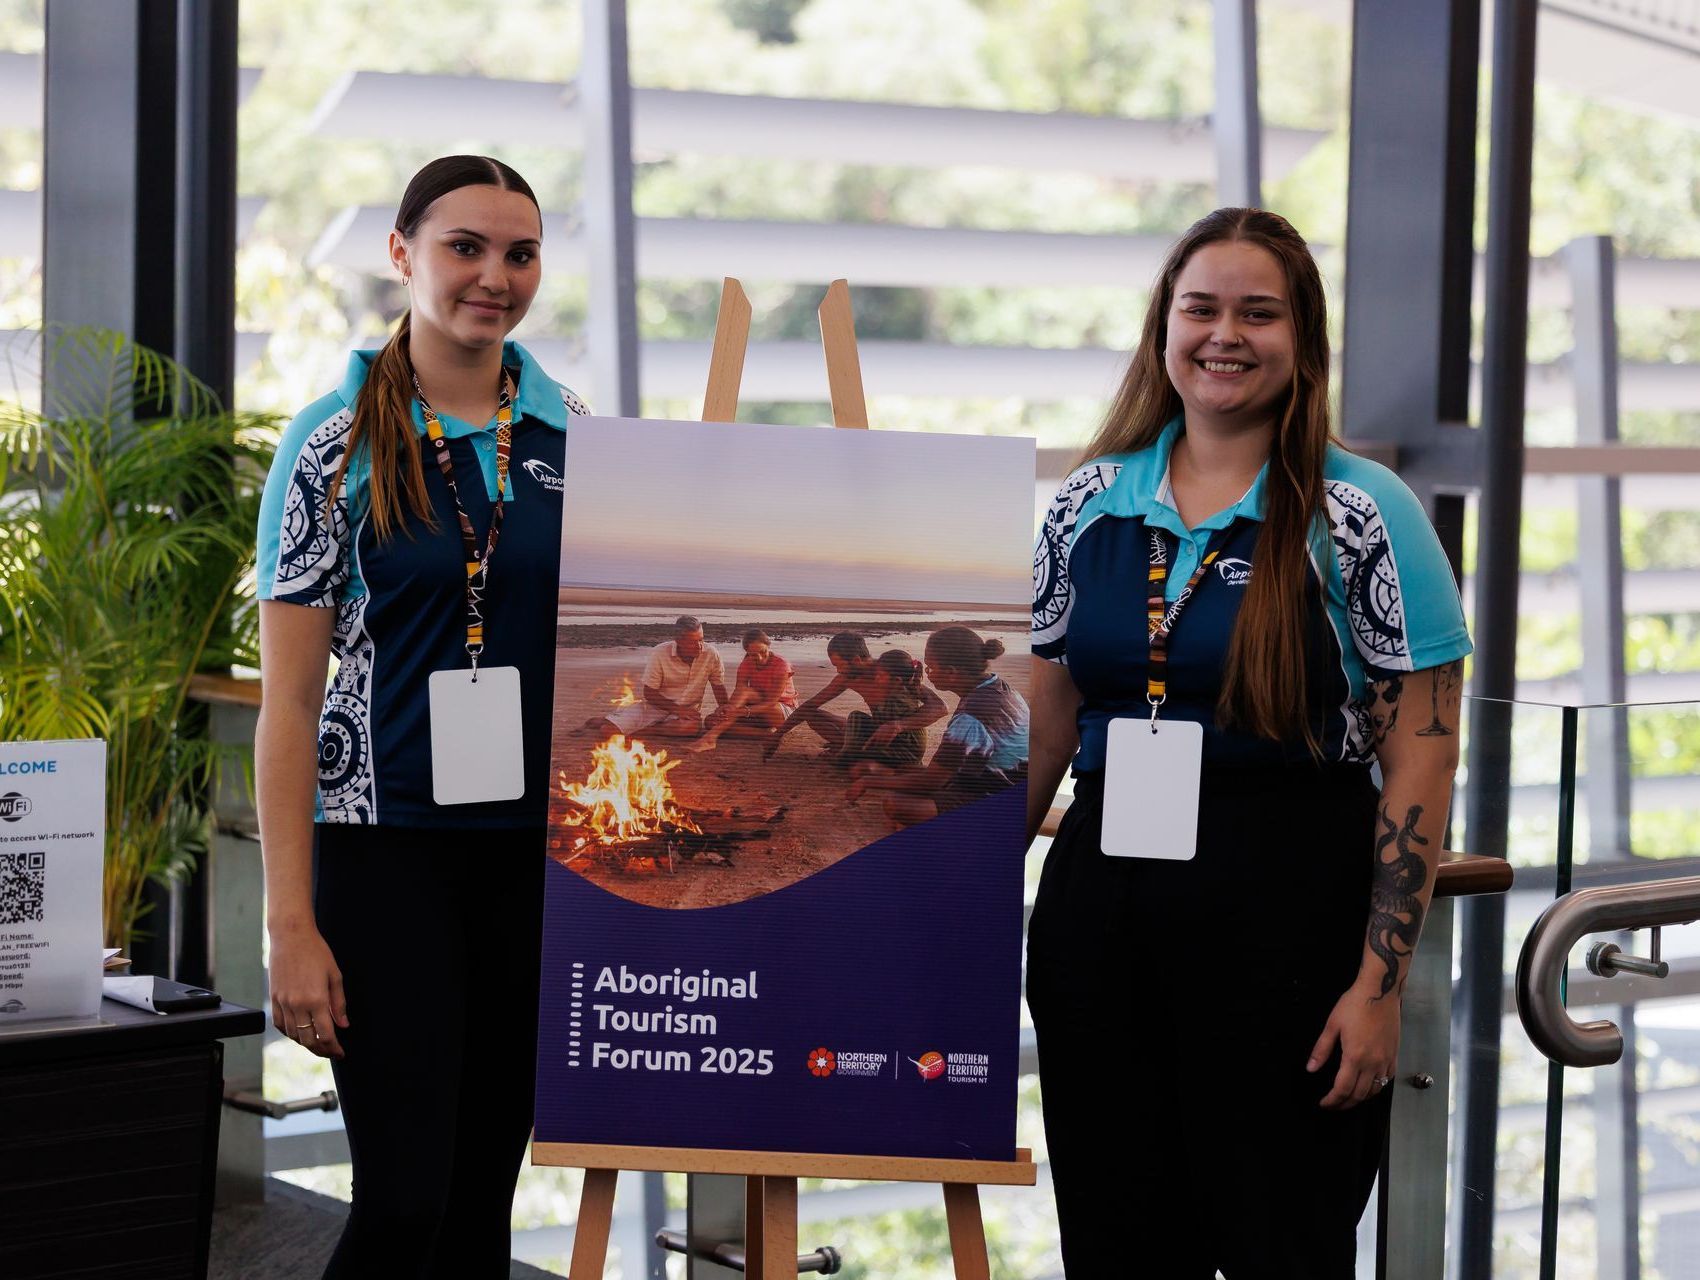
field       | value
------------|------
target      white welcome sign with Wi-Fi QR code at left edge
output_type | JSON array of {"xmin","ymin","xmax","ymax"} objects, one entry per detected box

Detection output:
[{"xmin": 0, "ymin": 738, "xmax": 105, "ymax": 1032}]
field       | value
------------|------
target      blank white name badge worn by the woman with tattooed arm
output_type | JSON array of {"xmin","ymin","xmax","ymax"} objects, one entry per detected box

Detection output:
[{"xmin": 1102, "ymin": 717, "xmax": 1204, "ymax": 862}]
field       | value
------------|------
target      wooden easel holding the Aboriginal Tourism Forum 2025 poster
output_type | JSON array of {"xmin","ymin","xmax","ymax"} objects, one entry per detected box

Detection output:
[{"xmin": 532, "ymin": 277, "xmax": 1039, "ymax": 1280}]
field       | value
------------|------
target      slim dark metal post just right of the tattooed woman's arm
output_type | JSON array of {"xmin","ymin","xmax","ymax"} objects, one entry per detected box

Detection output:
[{"xmin": 1454, "ymin": 0, "xmax": 1537, "ymax": 1277}]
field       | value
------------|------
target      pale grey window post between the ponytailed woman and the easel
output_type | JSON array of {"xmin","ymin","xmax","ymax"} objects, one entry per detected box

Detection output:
[{"xmin": 578, "ymin": 0, "xmax": 638, "ymax": 418}]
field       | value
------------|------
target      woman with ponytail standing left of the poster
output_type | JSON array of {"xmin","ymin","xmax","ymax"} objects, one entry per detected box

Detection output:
[{"xmin": 255, "ymin": 156, "xmax": 585, "ymax": 1277}]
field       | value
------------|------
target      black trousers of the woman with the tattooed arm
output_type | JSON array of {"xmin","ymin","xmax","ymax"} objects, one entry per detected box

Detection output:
[{"xmin": 1027, "ymin": 767, "xmax": 1391, "ymax": 1280}]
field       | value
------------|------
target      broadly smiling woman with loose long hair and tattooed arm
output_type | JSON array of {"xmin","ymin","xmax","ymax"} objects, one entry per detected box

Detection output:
[{"xmin": 1027, "ymin": 209, "xmax": 1471, "ymax": 1280}]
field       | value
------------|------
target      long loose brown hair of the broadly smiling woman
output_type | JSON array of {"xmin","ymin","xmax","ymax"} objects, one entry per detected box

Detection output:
[{"xmin": 1081, "ymin": 209, "xmax": 1333, "ymax": 755}]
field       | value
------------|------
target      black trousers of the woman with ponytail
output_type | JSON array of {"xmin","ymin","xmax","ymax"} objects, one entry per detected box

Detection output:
[{"xmin": 315, "ymin": 823, "xmax": 544, "ymax": 1280}]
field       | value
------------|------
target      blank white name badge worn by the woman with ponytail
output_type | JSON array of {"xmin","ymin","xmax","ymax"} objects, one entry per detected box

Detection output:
[{"xmin": 430, "ymin": 666, "xmax": 525, "ymax": 804}]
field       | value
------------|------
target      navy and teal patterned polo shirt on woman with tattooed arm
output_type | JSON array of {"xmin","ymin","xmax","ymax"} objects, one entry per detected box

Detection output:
[{"xmin": 1032, "ymin": 418, "xmax": 1471, "ymax": 773}]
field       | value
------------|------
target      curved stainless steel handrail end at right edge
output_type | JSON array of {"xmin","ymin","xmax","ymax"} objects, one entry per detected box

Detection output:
[{"xmin": 1516, "ymin": 875, "xmax": 1700, "ymax": 1068}]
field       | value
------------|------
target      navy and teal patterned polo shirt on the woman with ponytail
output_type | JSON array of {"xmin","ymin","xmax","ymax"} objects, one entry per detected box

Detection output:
[{"xmin": 258, "ymin": 342, "xmax": 588, "ymax": 828}]
